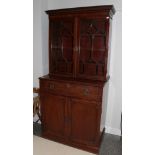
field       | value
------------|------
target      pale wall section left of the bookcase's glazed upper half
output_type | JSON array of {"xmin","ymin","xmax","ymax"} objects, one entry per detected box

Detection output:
[{"xmin": 33, "ymin": 0, "xmax": 48, "ymax": 87}]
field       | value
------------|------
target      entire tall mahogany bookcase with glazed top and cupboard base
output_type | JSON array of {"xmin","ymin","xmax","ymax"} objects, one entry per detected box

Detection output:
[{"xmin": 40, "ymin": 5, "xmax": 115, "ymax": 153}]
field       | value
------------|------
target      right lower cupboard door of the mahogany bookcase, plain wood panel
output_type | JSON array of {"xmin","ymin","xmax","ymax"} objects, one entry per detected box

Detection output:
[{"xmin": 70, "ymin": 99, "xmax": 100, "ymax": 145}]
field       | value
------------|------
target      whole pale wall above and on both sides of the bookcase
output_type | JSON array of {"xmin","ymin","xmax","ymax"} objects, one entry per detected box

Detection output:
[{"xmin": 34, "ymin": 0, "xmax": 122, "ymax": 135}]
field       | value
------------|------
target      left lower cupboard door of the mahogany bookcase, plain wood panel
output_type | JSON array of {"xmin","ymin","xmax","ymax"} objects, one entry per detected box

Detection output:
[{"xmin": 41, "ymin": 93, "xmax": 66, "ymax": 137}]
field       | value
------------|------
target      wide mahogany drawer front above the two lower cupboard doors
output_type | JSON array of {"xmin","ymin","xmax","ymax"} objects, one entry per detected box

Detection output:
[{"xmin": 40, "ymin": 80, "xmax": 102, "ymax": 101}]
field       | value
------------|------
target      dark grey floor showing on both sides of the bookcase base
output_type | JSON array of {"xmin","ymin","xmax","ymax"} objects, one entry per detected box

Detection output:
[{"xmin": 33, "ymin": 123, "xmax": 122, "ymax": 155}]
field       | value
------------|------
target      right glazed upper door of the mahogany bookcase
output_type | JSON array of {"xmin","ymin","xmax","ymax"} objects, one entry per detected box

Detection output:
[{"xmin": 77, "ymin": 18, "xmax": 108, "ymax": 80}]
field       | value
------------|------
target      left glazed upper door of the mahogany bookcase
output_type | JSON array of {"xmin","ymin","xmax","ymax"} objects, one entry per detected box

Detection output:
[{"xmin": 49, "ymin": 18, "xmax": 74, "ymax": 76}]
